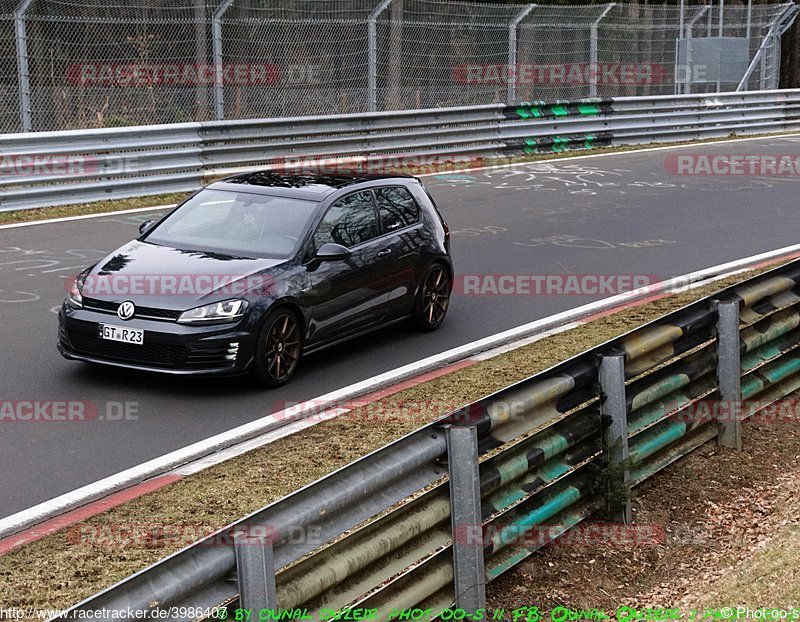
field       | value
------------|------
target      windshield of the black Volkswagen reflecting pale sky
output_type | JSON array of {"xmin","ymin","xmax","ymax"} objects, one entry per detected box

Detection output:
[{"xmin": 144, "ymin": 189, "xmax": 318, "ymax": 258}]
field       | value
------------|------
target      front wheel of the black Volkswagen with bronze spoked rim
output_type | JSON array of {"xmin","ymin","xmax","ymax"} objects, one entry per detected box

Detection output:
[{"xmin": 250, "ymin": 307, "xmax": 303, "ymax": 388}]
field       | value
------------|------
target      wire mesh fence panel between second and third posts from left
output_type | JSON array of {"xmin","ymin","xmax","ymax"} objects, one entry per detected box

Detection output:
[{"xmin": 217, "ymin": 1, "xmax": 373, "ymax": 118}]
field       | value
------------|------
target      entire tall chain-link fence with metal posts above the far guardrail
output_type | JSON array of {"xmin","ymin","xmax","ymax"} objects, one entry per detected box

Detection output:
[{"xmin": 0, "ymin": 0, "xmax": 798, "ymax": 132}]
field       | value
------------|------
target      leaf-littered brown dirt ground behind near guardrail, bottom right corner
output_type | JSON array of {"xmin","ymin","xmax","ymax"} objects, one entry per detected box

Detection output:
[{"xmin": 487, "ymin": 414, "xmax": 800, "ymax": 619}]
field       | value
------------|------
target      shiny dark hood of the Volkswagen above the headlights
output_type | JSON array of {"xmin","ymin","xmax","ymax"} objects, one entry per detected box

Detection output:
[{"xmin": 83, "ymin": 240, "xmax": 287, "ymax": 310}]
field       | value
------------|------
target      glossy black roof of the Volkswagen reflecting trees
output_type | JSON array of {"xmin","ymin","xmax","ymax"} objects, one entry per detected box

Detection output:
[{"xmin": 208, "ymin": 170, "xmax": 416, "ymax": 201}]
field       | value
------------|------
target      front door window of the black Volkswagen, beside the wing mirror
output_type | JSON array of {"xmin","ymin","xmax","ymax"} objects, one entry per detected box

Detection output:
[{"xmin": 314, "ymin": 192, "xmax": 378, "ymax": 248}]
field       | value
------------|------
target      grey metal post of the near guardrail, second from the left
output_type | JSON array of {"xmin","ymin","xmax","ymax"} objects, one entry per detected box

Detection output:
[{"xmin": 445, "ymin": 425, "xmax": 486, "ymax": 612}]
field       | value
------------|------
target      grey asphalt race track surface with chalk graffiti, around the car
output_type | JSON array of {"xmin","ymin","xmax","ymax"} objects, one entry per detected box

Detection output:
[{"xmin": 0, "ymin": 137, "xmax": 800, "ymax": 517}]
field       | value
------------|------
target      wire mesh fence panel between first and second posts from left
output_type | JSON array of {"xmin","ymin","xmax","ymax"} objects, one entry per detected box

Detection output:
[{"xmin": 26, "ymin": 0, "xmax": 214, "ymax": 130}]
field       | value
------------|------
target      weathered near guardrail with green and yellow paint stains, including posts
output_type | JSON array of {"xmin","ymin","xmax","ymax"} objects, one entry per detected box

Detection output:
[{"xmin": 61, "ymin": 260, "xmax": 800, "ymax": 619}]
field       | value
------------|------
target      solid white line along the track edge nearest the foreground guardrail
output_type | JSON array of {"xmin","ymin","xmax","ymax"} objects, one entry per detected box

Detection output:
[{"xmin": 0, "ymin": 244, "xmax": 800, "ymax": 539}]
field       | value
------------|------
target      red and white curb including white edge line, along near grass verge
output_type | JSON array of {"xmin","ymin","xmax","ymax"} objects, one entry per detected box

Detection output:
[{"xmin": 0, "ymin": 244, "xmax": 800, "ymax": 555}]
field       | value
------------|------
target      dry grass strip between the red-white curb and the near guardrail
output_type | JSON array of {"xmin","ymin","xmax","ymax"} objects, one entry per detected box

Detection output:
[{"xmin": 0, "ymin": 262, "xmax": 792, "ymax": 609}]
